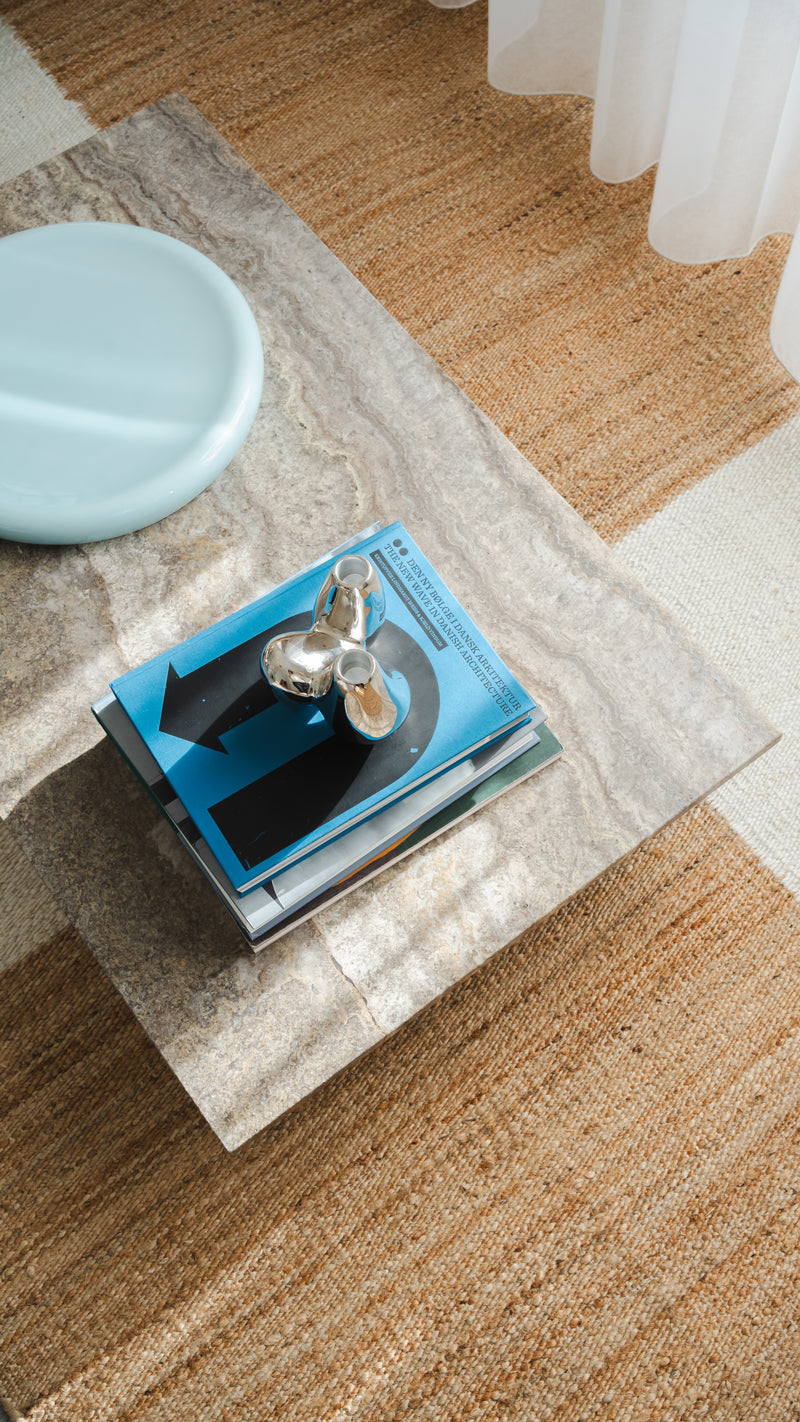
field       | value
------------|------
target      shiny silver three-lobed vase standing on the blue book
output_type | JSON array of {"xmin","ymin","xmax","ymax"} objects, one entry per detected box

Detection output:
[{"xmin": 261, "ymin": 553, "xmax": 408, "ymax": 742}]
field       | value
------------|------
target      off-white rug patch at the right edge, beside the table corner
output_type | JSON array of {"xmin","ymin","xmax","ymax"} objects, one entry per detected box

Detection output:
[{"xmin": 617, "ymin": 411, "xmax": 800, "ymax": 896}]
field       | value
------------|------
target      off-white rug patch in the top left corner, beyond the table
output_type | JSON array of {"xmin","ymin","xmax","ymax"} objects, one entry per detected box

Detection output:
[{"xmin": 0, "ymin": 20, "xmax": 97, "ymax": 182}]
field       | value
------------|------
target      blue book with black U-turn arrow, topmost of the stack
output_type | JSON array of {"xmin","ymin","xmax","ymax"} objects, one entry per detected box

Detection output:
[{"xmin": 111, "ymin": 523, "xmax": 544, "ymax": 893}]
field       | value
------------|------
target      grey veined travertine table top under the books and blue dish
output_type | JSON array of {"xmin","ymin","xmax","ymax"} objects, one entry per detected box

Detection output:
[{"xmin": 0, "ymin": 97, "xmax": 776, "ymax": 1149}]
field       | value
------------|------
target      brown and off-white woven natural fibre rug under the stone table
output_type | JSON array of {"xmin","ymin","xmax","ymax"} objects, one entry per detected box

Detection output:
[{"xmin": 0, "ymin": 0, "xmax": 800, "ymax": 1422}]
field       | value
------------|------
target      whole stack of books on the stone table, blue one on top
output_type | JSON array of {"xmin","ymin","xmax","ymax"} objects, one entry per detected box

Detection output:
[{"xmin": 92, "ymin": 523, "xmax": 561, "ymax": 948}]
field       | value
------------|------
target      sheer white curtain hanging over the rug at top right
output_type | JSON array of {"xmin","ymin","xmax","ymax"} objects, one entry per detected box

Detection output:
[{"xmin": 433, "ymin": 0, "xmax": 800, "ymax": 380}]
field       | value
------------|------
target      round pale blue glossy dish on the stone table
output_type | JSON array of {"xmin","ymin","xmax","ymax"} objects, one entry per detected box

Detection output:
[{"xmin": 0, "ymin": 222, "xmax": 264, "ymax": 543}]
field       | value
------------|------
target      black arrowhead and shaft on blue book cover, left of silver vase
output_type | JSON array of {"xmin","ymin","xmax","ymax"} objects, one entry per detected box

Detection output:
[{"xmin": 159, "ymin": 609, "xmax": 313, "ymax": 755}]
